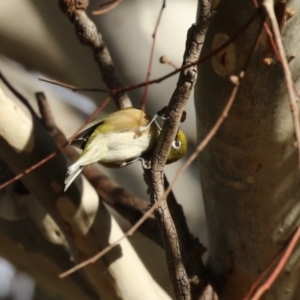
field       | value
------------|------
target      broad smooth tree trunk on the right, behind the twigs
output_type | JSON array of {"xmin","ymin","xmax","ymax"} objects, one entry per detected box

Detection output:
[{"xmin": 195, "ymin": 0, "xmax": 300, "ymax": 300}]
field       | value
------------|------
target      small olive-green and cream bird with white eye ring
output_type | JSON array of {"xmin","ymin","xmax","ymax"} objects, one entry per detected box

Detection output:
[{"xmin": 65, "ymin": 107, "xmax": 187, "ymax": 191}]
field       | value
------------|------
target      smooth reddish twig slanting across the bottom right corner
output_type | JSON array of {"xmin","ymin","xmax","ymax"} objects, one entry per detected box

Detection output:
[{"xmin": 251, "ymin": 227, "xmax": 300, "ymax": 300}]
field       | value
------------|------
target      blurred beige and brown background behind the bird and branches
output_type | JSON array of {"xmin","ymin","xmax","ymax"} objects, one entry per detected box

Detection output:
[{"xmin": 0, "ymin": 0, "xmax": 207, "ymax": 300}]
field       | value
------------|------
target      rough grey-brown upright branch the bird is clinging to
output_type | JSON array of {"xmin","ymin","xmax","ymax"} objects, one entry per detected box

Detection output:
[{"xmin": 147, "ymin": 1, "xmax": 211, "ymax": 299}]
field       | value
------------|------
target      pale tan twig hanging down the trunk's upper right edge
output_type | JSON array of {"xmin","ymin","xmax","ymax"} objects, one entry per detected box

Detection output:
[{"xmin": 263, "ymin": 0, "xmax": 300, "ymax": 169}]
